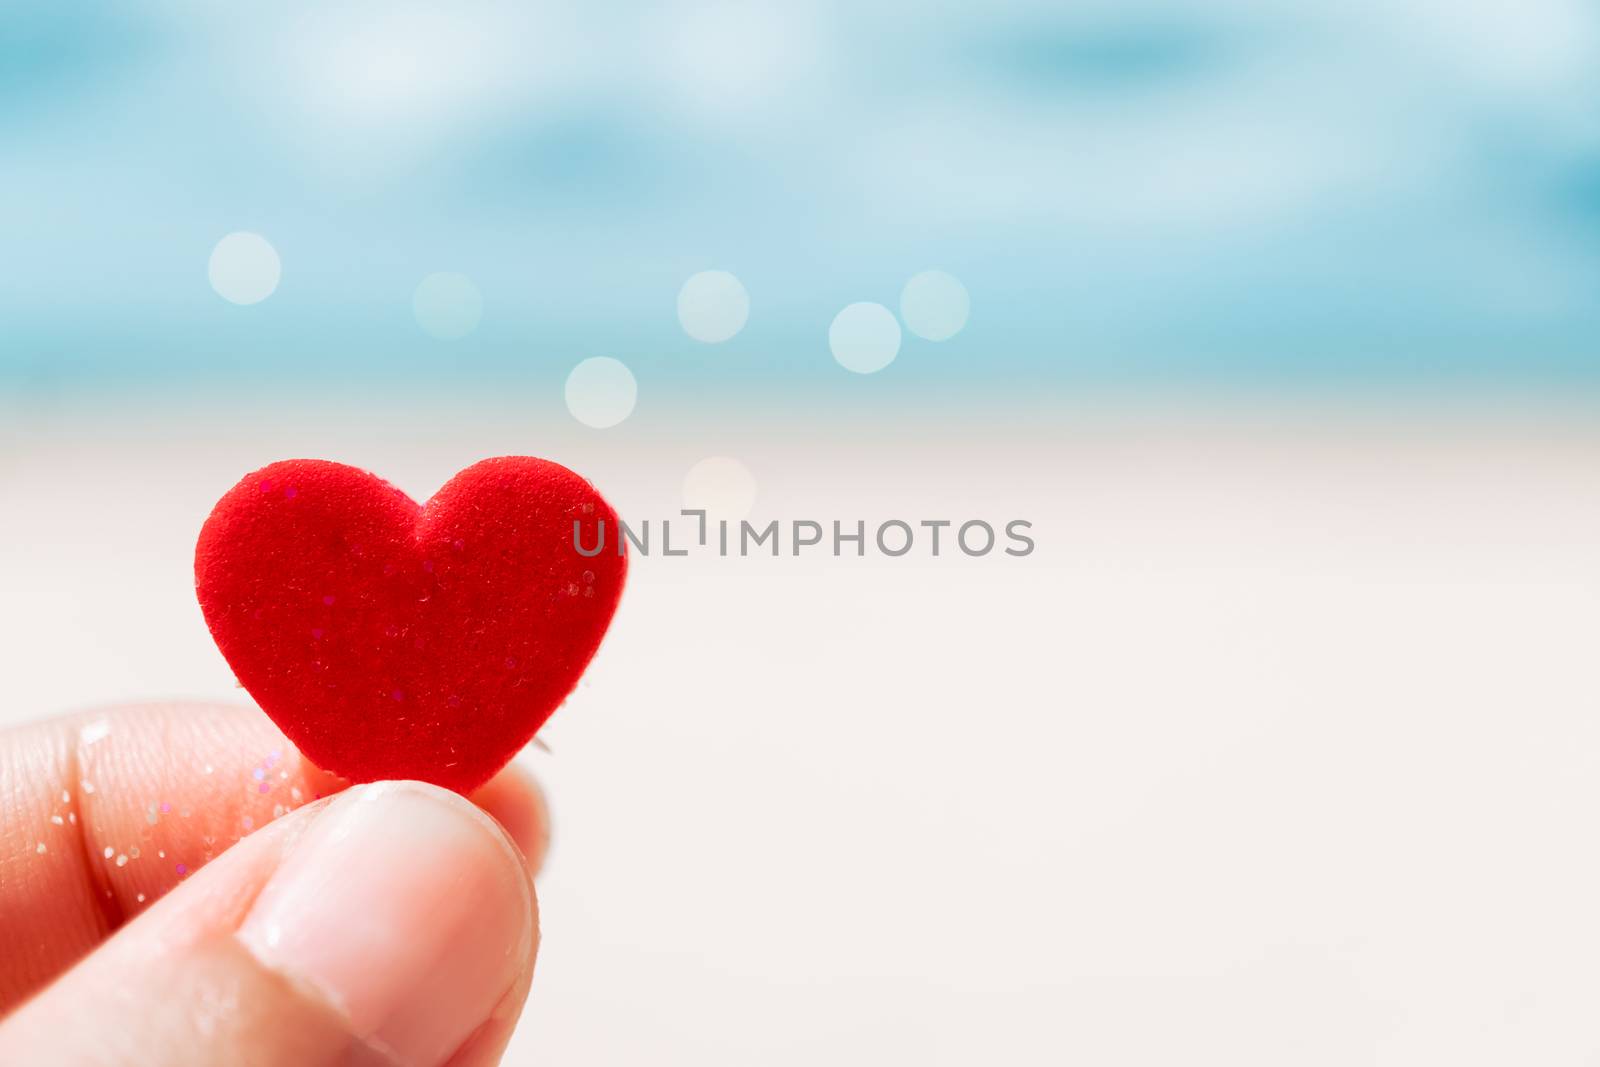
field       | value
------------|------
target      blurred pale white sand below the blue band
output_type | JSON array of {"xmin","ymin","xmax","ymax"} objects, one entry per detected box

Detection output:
[{"xmin": 0, "ymin": 400, "xmax": 1600, "ymax": 1067}]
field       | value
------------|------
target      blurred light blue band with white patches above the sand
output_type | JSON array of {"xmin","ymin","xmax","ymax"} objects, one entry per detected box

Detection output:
[{"xmin": 0, "ymin": 0, "xmax": 1600, "ymax": 394}]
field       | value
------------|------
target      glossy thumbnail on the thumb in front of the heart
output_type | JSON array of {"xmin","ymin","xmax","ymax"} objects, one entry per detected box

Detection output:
[{"xmin": 238, "ymin": 782, "xmax": 534, "ymax": 1067}]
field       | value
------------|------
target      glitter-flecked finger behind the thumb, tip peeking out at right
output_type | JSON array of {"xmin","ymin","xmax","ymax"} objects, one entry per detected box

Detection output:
[{"xmin": 0, "ymin": 704, "xmax": 547, "ymax": 1014}]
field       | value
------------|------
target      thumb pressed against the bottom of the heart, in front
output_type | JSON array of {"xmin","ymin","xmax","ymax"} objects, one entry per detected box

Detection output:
[{"xmin": 0, "ymin": 782, "xmax": 538, "ymax": 1067}]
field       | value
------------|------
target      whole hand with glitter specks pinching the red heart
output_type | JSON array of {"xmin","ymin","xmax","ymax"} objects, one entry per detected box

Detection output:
[{"xmin": 0, "ymin": 705, "xmax": 547, "ymax": 1067}]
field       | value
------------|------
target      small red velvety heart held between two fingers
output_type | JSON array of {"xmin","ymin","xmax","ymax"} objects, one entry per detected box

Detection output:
[{"xmin": 195, "ymin": 456, "xmax": 627, "ymax": 792}]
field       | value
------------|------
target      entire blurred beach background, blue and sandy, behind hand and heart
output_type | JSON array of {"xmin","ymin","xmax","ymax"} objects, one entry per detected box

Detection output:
[{"xmin": 0, "ymin": 0, "xmax": 1600, "ymax": 1067}]
